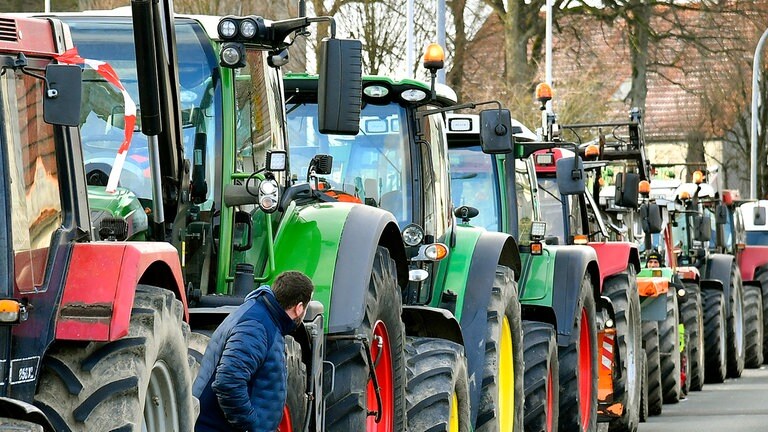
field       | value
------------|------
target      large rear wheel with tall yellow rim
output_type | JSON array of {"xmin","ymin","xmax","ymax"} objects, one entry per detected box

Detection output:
[{"xmin": 475, "ymin": 265, "xmax": 525, "ymax": 432}]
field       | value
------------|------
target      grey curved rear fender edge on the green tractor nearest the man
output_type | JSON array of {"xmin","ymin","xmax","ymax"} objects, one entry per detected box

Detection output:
[{"xmin": 328, "ymin": 205, "xmax": 408, "ymax": 333}]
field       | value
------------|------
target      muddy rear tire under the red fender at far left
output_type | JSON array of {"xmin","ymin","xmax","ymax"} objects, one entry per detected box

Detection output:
[{"xmin": 34, "ymin": 285, "xmax": 195, "ymax": 432}]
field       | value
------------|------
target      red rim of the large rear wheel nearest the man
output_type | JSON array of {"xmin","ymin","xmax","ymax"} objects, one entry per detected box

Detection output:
[{"xmin": 366, "ymin": 321, "xmax": 395, "ymax": 432}]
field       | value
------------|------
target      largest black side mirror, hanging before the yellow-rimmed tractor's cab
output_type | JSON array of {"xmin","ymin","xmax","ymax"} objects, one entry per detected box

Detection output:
[{"xmin": 317, "ymin": 38, "xmax": 363, "ymax": 135}]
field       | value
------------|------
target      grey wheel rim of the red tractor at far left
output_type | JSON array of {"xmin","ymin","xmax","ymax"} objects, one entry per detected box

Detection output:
[{"xmin": 141, "ymin": 361, "xmax": 179, "ymax": 432}]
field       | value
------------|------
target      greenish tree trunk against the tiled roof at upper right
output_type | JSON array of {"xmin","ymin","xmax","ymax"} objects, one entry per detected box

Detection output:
[{"xmin": 627, "ymin": 3, "xmax": 651, "ymax": 111}]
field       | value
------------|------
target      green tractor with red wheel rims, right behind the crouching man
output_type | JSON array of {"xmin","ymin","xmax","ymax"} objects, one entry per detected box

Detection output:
[{"xmin": 48, "ymin": 6, "xmax": 424, "ymax": 431}]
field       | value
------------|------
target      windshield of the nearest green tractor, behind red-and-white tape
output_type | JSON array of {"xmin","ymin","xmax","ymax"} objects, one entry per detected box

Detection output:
[{"xmin": 62, "ymin": 17, "xmax": 221, "ymax": 207}]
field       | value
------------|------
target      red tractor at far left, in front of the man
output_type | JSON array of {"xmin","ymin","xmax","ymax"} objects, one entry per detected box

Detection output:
[{"xmin": 0, "ymin": 16, "xmax": 196, "ymax": 431}]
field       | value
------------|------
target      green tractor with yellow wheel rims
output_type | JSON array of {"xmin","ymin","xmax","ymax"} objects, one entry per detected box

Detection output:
[{"xmin": 284, "ymin": 61, "xmax": 523, "ymax": 431}]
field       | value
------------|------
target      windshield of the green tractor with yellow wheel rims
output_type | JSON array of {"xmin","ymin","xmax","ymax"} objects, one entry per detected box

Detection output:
[{"xmin": 287, "ymin": 103, "xmax": 411, "ymax": 226}]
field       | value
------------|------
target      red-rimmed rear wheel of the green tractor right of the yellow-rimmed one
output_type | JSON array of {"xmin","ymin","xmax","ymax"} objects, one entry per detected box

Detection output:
[{"xmin": 558, "ymin": 275, "xmax": 597, "ymax": 432}]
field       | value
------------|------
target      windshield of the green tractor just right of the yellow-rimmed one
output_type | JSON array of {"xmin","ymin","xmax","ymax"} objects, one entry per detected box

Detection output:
[{"xmin": 449, "ymin": 146, "xmax": 501, "ymax": 231}]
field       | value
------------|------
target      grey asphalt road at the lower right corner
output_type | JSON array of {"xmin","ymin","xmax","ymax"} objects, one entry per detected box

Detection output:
[{"xmin": 639, "ymin": 365, "xmax": 768, "ymax": 432}]
